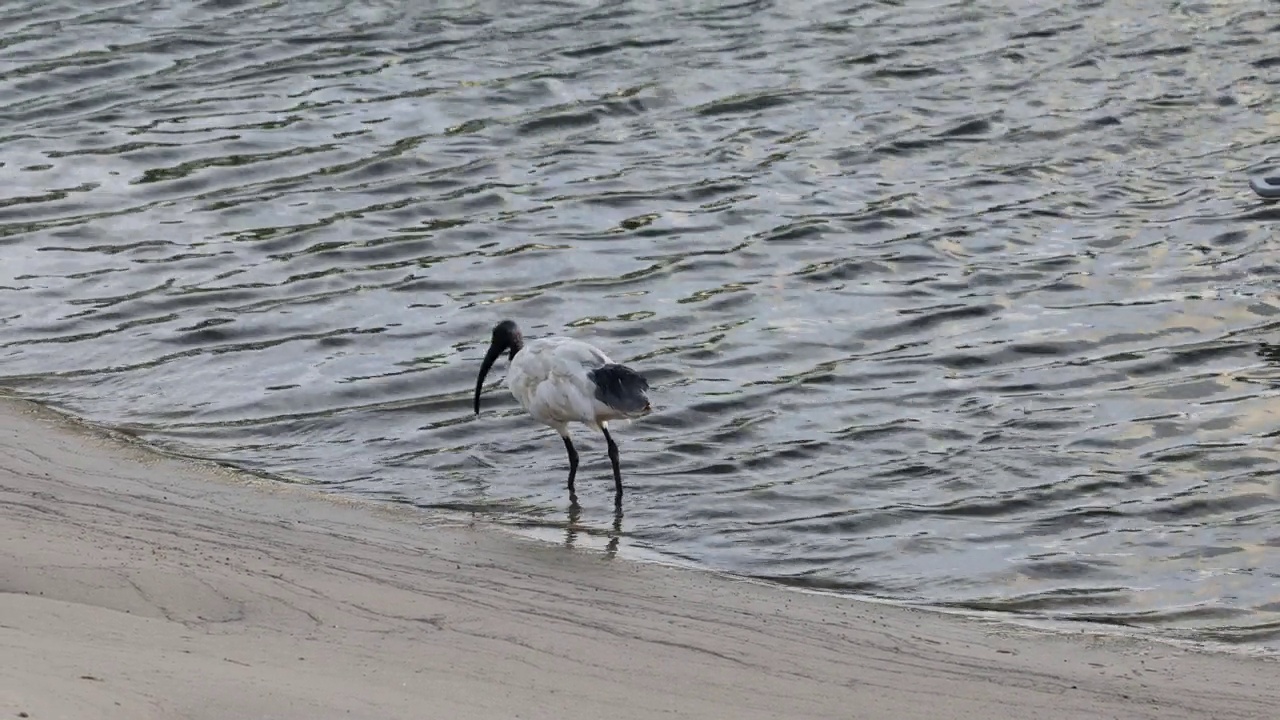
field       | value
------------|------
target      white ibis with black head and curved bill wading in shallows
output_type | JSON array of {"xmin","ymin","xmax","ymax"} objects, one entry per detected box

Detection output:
[{"xmin": 476, "ymin": 320, "xmax": 650, "ymax": 510}]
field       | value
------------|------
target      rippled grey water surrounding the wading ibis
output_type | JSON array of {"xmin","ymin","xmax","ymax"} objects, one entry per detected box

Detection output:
[{"xmin": 0, "ymin": 0, "xmax": 1280, "ymax": 643}]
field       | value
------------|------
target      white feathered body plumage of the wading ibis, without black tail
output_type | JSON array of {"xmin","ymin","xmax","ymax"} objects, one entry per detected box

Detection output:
[{"xmin": 507, "ymin": 337, "xmax": 649, "ymax": 434}]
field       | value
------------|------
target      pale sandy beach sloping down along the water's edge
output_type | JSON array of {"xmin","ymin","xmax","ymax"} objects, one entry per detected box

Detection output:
[{"xmin": 0, "ymin": 400, "xmax": 1280, "ymax": 720}]
